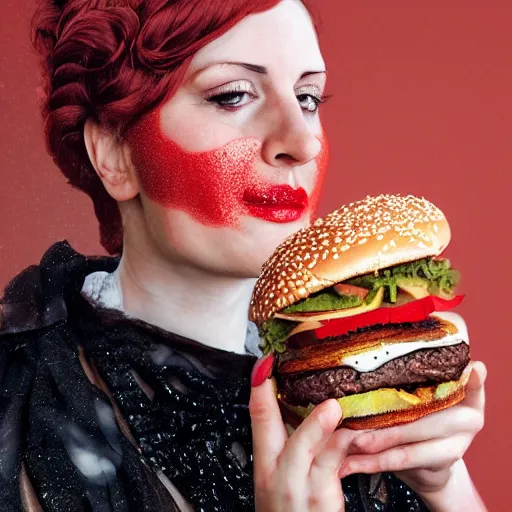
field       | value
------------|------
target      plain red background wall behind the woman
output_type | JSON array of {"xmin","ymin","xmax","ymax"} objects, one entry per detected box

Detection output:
[{"xmin": 0, "ymin": 0, "xmax": 512, "ymax": 511}]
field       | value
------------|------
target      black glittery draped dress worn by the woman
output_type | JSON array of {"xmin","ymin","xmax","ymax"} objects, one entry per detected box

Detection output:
[{"xmin": 0, "ymin": 242, "xmax": 427, "ymax": 512}]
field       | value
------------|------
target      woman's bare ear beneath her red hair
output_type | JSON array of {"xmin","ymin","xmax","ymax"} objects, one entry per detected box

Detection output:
[{"xmin": 84, "ymin": 119, "xmax": 139, "ymax": 202}]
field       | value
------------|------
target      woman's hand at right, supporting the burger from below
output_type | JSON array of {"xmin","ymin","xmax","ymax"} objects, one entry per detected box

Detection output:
[{"xmin": 340, "ymin": 362, "xmax": 487, "ymax": 512}]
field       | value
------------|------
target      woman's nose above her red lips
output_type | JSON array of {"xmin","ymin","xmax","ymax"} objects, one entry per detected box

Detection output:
[{"xmin": 262, "ymin": 100, "xmax": 322, "ymax": 167}]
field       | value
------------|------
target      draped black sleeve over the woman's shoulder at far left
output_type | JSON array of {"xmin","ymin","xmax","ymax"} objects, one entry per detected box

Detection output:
[{"xmin": 0, "ymin": 246, "xmax": 181, "ymax": 512}]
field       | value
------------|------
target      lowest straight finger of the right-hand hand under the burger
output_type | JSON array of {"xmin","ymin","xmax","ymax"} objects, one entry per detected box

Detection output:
[{"xmin": 340, "ymin": 434, "xmax": 471, "ymax": 477}]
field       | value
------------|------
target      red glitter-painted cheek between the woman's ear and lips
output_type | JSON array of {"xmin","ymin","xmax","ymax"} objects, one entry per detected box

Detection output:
[{"xmin": 129, "ymin": 110, "xmax": 261, "ymax": 228}]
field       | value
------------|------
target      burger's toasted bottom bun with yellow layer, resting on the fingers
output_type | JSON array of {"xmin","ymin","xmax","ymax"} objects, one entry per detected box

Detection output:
[{"xmin": 278, "ymin": 363, "xmax": 471, "ymax": 430}]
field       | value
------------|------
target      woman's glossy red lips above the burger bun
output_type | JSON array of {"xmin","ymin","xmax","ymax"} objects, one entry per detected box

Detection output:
[{"xmin": 243, "ymin": 185, "xmax": 309, "ymax": 223}]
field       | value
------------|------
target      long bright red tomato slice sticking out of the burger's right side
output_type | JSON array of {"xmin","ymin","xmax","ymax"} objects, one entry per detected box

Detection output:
[{"xmin": 315, "ymin": 295, "xmax": 464, "ymax": 339}]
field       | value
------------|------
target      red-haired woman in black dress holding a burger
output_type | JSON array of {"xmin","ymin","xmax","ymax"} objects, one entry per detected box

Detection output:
[{"xmin": 0, "ymin": 0, "xmax": 485, "ymax": 511}]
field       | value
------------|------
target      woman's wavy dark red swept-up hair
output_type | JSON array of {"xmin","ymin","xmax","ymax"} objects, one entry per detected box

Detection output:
[{"xmin": 32, "ymin": 0, "xmax": 318, "ymax": 254}]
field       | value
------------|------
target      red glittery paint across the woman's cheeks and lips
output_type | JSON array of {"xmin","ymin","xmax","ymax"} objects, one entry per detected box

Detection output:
[{"xmin": 128, "ymin": 109, "xmax": 325, "ymax": 228}]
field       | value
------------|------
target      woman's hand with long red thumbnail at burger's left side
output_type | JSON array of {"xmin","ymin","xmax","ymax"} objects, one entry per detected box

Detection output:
[{"xmin": 249, "ymin": 356, "xmax": 355, "ymax": 512}]
